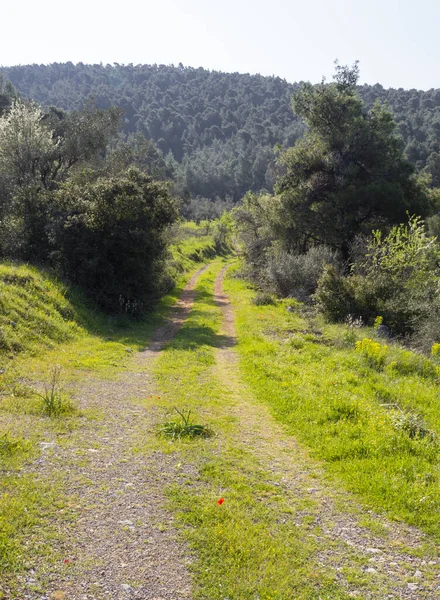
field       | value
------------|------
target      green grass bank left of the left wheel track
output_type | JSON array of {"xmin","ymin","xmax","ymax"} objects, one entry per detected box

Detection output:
[{"xmin": 0, "ymin": 224, "xmax": 220, "ymax": 584}]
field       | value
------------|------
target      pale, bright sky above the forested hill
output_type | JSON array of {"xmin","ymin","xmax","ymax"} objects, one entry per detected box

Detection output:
[{"xmin": 0, "ymin": 0, "xmax": 440, "ymax": 89}]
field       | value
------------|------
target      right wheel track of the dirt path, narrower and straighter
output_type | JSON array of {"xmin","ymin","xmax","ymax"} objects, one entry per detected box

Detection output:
[{"xmin": 214, "ymin": 269, "xmax": 440, "ymax": 600}]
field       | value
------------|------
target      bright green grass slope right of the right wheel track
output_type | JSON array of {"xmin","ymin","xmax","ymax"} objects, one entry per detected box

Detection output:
[{"xmin": 227, "ymin": 268, "xmax": 440, "ymax": 541}]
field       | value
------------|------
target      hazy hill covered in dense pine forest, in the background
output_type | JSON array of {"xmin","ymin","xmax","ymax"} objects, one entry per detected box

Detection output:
[{"xmin": 2, "ymin": 63, "xmax": 440, "ymax": 200}]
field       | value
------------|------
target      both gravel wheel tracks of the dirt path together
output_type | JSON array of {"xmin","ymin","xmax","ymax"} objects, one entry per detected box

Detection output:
[{"xmin": 6, "ymin": 269, "xmax": 440, "ymax": 600}]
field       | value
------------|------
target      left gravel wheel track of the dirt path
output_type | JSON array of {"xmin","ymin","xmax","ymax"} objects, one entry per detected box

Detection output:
[{"xmin": 12, "ymin": 267, "xmax": 206, "ymax": 600}]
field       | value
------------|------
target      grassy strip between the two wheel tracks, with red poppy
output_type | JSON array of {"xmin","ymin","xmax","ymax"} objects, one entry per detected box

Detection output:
[{"xmin": 148, "ymin": 262, "xmax": 350, "ymax": 600}]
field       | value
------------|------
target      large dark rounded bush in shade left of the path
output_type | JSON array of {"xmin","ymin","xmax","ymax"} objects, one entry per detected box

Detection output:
[{"xmin": 53, "ymin": 168, "xmax": 177, "ymax": 316}]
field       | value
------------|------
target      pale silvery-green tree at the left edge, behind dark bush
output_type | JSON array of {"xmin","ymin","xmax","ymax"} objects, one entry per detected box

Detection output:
[{"xmin": 0, "ymin": 100, "xmax": 120, "ymax": 262}]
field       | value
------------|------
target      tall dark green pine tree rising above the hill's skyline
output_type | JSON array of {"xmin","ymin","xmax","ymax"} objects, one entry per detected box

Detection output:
[{"xmin": 277, "ymin": 65, "xmax": 429, "ymax": 258}]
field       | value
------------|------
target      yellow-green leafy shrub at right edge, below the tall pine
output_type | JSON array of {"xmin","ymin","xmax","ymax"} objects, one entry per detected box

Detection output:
[{"xmin": 315, "ymin": 217, "xmax": 440, "ymax": 340}]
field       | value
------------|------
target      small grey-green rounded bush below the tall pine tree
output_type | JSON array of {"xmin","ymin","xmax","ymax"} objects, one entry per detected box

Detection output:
[{"xmin": 267, "ymin": 246, "xmax": 338, "ymax": 300}]
